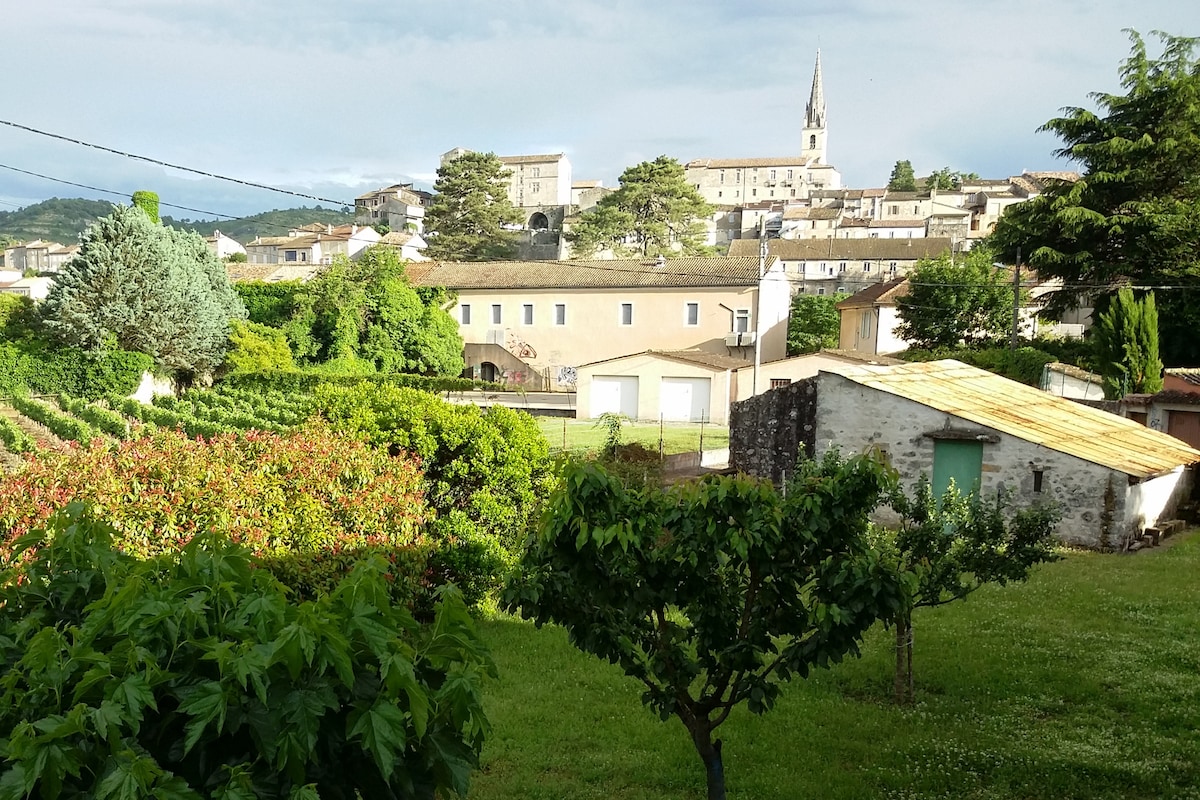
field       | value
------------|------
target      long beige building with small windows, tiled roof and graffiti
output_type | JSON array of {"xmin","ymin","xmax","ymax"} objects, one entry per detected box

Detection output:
[{"xmin": 413, "ymin": 257, "xmax": 791, "ymax": 391}]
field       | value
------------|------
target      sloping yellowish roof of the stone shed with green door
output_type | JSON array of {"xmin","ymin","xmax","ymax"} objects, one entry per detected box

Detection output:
[{"xmin": 828, "ymin": 359, "xmax": 1200, "ymax": 479}]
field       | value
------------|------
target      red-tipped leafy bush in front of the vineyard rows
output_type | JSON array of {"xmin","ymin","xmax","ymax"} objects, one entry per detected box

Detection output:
[{"xmin": 0, "ymin": 425, "xmax": 428, "ymax": 599}]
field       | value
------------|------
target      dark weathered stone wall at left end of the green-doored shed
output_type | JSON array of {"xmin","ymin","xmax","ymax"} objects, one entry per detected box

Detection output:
[{"xmin": 730, "ymin": 378, "xmax": 817, "ymax": 483}]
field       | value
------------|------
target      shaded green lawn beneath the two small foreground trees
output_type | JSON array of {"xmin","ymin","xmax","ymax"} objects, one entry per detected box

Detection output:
[{"xmin": 469, "ymin": 533, "xmax": 1200, "ymax": 800}]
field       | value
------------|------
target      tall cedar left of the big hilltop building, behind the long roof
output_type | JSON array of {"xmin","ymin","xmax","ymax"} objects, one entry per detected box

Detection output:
[{"xmin": 425, "ymin": 152, "xmax": 523, "ymax": 261}]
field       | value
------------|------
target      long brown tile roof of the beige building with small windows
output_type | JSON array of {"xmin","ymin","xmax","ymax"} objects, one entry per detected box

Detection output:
[{"xmin": 413, "ymin": 256, "xmax": 774, "ymax": 289}]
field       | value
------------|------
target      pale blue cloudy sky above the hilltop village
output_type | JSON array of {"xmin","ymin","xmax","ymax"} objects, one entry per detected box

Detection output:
[{"xmin": 0, "ymin": 0, "xmax": 1200, "ymax": 219}]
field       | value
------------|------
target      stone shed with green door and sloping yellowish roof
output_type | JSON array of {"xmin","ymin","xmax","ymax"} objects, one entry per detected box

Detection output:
[{"xmin": 730, "ymin": 360, "xmax": 1200, "ymax": 549}]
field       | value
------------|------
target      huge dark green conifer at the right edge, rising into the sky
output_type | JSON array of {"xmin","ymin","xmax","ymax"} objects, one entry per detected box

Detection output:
[{"xmin": 990, "ymin": 31, "xmax": 1200, "ymax": 366}]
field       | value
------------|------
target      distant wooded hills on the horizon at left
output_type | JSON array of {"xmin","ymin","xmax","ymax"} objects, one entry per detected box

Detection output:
[{"xmin": 0, "ymin": 198, "xmax": 354, "ymax": 245}]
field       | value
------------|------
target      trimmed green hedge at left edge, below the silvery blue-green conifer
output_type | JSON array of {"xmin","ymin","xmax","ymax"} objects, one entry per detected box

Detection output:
[{"xmin": 0, "ymin": 342, "xmax": 154, "ymax": 399}]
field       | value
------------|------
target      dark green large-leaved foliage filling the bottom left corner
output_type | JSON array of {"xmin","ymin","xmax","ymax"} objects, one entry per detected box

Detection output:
[{"xmin": 0, "ymin": 505, "xmax": 494, "ymax": 800}]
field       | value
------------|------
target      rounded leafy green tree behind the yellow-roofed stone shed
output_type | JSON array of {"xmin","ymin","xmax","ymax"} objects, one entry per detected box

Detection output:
[{"xmin": 895, "ymin": 247, "xmax": 1013, "ymax": 348}]
